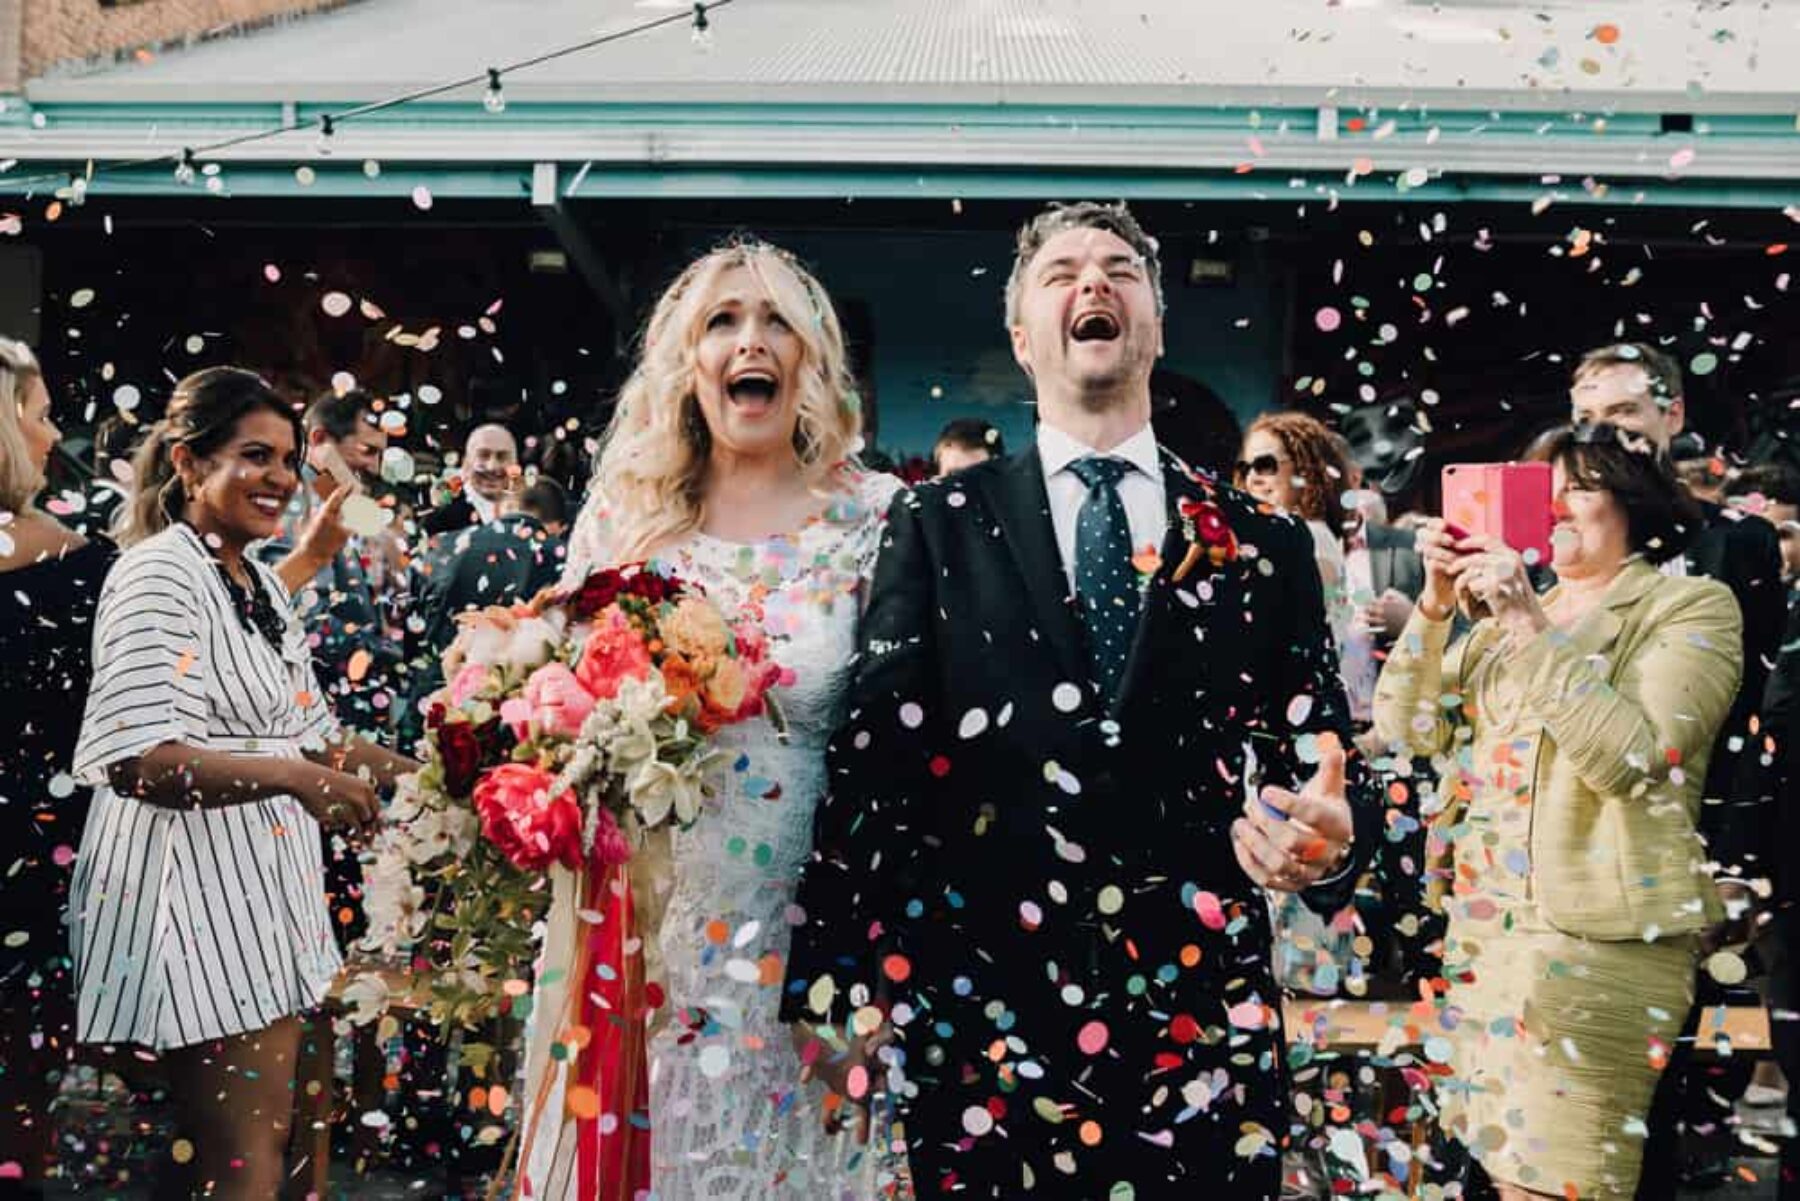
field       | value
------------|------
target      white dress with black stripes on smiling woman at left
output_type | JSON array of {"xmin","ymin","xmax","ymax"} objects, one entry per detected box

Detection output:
[{"xmin": 68, "ymin": 524, "xmax": 342, "ymax": 1050}]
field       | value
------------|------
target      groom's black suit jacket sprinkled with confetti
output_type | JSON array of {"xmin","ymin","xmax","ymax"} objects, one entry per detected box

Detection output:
[{"xmin": 783, "ymin": 448, "xmax": 1381, "ymax": 1197}]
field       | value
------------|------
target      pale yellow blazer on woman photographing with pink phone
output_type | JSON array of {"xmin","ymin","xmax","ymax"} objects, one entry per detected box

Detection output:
[{"xmin": 1375, "ymin": 560, "xmax": 1744, "ymax": 940}]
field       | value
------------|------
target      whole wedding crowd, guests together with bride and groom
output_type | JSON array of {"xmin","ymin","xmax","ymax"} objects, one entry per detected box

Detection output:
[{"xmin": 0, "ymin": 203, "xmax": 1800, "ymax": 1201}]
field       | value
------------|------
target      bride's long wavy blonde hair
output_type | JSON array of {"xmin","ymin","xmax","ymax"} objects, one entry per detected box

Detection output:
[{"xmin": 580, "ymin": 238, "xmax": 862, "ymax": 562}]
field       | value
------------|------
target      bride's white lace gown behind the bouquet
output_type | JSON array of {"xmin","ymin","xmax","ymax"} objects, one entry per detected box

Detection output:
[{"xmin": 529, "ymin": 474, "xmax": 900, "ymax": 1201}]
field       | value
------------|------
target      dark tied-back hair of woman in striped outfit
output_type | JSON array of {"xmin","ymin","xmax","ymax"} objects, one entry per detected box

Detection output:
[{"xmin": 115, "ymin": 367, "xmax": 306, "ymax": 546}]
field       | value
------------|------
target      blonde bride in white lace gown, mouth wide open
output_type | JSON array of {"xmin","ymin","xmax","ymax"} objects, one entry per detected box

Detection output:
[{"xmin": 520, "ymin": 241, "xmax": 898, "ymax": 1201}]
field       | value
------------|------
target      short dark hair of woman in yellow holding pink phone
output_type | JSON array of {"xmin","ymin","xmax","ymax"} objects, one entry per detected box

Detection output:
[{"xmin": 1526, "ymin": 421, "xmax": 1706, "ymax": 564}]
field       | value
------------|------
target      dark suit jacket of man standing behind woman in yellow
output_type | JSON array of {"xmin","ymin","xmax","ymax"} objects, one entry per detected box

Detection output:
[{"xmin": 1687, "ymin": 504, "xmax": 1787, "ymax": 879}]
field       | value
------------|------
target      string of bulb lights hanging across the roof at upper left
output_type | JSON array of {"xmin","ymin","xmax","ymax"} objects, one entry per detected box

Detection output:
[{"xmin": 0, "ymin": 0, "xmax": 733, "ymax": 205}]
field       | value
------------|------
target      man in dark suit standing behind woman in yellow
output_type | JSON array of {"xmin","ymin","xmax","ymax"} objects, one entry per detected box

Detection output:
[{"xmin": 1570, "ymin": 342, "xmax": 1786, "ymax": 1201}]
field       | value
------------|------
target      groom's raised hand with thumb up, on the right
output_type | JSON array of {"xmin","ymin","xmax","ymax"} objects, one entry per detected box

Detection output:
[{"xmin": 1231, "ymin": 731, "xmax": 1354, "ymax": 893}]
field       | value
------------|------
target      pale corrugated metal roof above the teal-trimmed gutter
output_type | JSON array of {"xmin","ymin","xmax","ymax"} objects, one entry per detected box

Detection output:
[{"xmin": 27, "ymin": 0, "xmax": 1800, "ymax": 113}]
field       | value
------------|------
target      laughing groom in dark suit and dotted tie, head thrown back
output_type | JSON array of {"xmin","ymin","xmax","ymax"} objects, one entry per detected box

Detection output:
[{"xmin": 783, "ymin": 203, "xmax": 1379, "ymax": 1201}]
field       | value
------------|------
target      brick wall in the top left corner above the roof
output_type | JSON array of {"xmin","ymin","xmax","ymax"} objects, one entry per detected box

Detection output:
[{"xmin": 17, "ymin": 0, "xmax": 346, "ymax": 86}]
